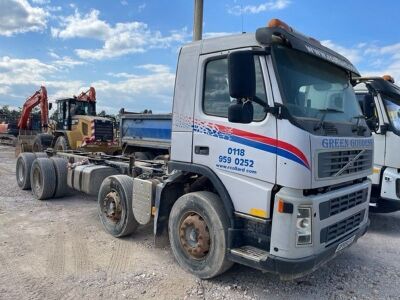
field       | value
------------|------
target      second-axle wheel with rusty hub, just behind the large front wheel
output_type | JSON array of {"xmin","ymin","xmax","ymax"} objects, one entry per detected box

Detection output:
[{"xmin": 97, "ymin": 175, "xmax": 139, "ymax": 237}]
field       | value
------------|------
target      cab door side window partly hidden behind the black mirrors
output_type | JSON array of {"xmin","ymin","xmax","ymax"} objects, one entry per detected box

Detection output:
[{"xmin": 203, "ymin": 56, "xmax": 267, "ymax": 121}]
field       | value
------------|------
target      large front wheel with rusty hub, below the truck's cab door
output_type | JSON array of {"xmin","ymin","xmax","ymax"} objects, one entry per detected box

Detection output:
[{"xmin": 168, "ymin": 191, "xmax": 233, "ymax": 279}]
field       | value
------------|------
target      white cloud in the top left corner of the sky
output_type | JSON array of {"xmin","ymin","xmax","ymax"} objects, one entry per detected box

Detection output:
[{"xmin": 0, "ymin": 0, "xmax": 47, "ymax": 36}]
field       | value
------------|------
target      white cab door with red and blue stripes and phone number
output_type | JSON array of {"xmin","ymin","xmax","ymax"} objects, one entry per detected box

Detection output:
[{"xmin": 192, "ymin": 53, "xmax": 276, "ymax": 218}]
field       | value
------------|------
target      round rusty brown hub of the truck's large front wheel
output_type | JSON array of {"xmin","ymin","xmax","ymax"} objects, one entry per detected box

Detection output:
[{"xmin": 179, "ymin": 213, "xmax": 211, "ymax": 259}]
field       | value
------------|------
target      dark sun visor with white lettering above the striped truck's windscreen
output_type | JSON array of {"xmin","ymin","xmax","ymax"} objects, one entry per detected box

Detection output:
[{"xmin": 256, "ymin": 27, "xmax": 360, "ymax": 77}]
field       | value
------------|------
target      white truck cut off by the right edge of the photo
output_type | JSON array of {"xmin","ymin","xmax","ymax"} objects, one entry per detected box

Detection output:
[{"xmin": 355, "ymin": 75, "xmax": 400, "ymax": 212}]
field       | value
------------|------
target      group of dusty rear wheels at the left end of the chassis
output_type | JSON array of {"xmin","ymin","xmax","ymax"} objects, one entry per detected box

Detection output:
[{"xmin": 16, "ymin": 152, "xmax": 68, "ymax": 200}]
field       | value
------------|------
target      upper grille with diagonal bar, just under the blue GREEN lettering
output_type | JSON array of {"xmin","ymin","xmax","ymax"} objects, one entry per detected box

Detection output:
[{"xmin": 318, "ymin": 150, "xmax": 373, "ymax": 178}]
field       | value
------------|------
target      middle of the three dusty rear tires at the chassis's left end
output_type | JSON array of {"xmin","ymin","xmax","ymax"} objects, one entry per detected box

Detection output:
[{"xmin": 31, "ymin": 158, "xmax": 56, "ymax": 200}]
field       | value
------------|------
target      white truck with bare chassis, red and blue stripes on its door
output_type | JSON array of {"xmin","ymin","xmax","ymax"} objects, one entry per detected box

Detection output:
[{"xmin": 16, "ymin": 19, "xmax": 373, "ymax": 279}]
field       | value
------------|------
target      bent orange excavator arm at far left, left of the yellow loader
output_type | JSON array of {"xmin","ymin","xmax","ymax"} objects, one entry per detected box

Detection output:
[{"xmin": 18, "ymin": 86, "xmax": 49, "ymax": 129}]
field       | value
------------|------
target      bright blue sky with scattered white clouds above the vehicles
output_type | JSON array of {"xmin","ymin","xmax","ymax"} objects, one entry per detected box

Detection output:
[{"xmin": 0, "ymin": 0, "xmax": 400, "ymax": 113}]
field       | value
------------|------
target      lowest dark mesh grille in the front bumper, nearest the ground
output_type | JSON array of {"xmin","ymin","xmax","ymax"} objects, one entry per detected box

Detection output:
[{"xmin": 320, "ymin": 209, "xmax": 365, "ymax": 244}]
